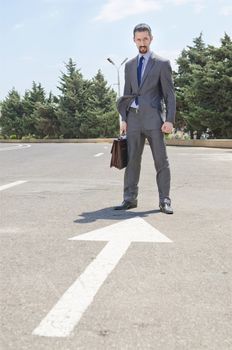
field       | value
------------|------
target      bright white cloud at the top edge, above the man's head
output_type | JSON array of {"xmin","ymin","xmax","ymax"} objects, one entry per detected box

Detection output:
[{"xmin": 95, "ymin": 0, "xmax": 161, "ymax": 22}]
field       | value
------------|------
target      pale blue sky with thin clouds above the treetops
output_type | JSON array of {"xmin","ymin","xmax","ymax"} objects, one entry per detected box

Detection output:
[{"xmin": 0, "ymin": 0, "xmax": 232, "ymax": 100}]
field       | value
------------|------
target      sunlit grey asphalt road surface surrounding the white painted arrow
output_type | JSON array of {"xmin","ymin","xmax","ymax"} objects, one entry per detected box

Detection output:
[{"xmin": 0, "ymin": 144, "xmax": 232, "ymax": 350}]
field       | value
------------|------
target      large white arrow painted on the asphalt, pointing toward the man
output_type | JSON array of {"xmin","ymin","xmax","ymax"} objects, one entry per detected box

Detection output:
[{"xmin": 33, "ymin": 217, "xmax": 172, "ymax": 337}]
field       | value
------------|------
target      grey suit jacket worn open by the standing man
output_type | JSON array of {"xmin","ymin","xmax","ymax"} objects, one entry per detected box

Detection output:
[{"xmin": 117, "ymin": 52, "xmax": 176, "ymax": 130}]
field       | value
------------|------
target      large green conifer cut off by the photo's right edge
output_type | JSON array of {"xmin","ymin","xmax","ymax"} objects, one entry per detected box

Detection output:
[{"xmin": 191, "ymin": 34, "xmax": 232, "ymax": 138}]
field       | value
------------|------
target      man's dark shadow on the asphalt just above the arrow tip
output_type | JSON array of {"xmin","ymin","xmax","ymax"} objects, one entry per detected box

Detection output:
[{"xmin": 74, "ymin": 207, "xmax": 160, "ymax": 224}]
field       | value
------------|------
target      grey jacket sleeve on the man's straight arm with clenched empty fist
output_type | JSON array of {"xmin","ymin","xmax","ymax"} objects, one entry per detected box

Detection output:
[{"xmin": 160, "ymin": 61, "xmax": 176, "ymax": 124}]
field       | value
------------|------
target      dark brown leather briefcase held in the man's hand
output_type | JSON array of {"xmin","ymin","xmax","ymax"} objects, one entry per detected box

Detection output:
[{"xmin": 110, "ymin": 138, "xmax": 127, "ymax": 169}]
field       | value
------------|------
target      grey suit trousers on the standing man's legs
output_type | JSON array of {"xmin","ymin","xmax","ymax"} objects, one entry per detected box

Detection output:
[{"xmin": 124, "ymin": 112, "xmax": 171, "ymax": 202}]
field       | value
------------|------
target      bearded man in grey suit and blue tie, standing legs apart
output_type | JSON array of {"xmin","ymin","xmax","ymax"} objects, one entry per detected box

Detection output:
[{"xmin": 114, "ymin": 23, "xmax": 176, "ymax": 214}]
